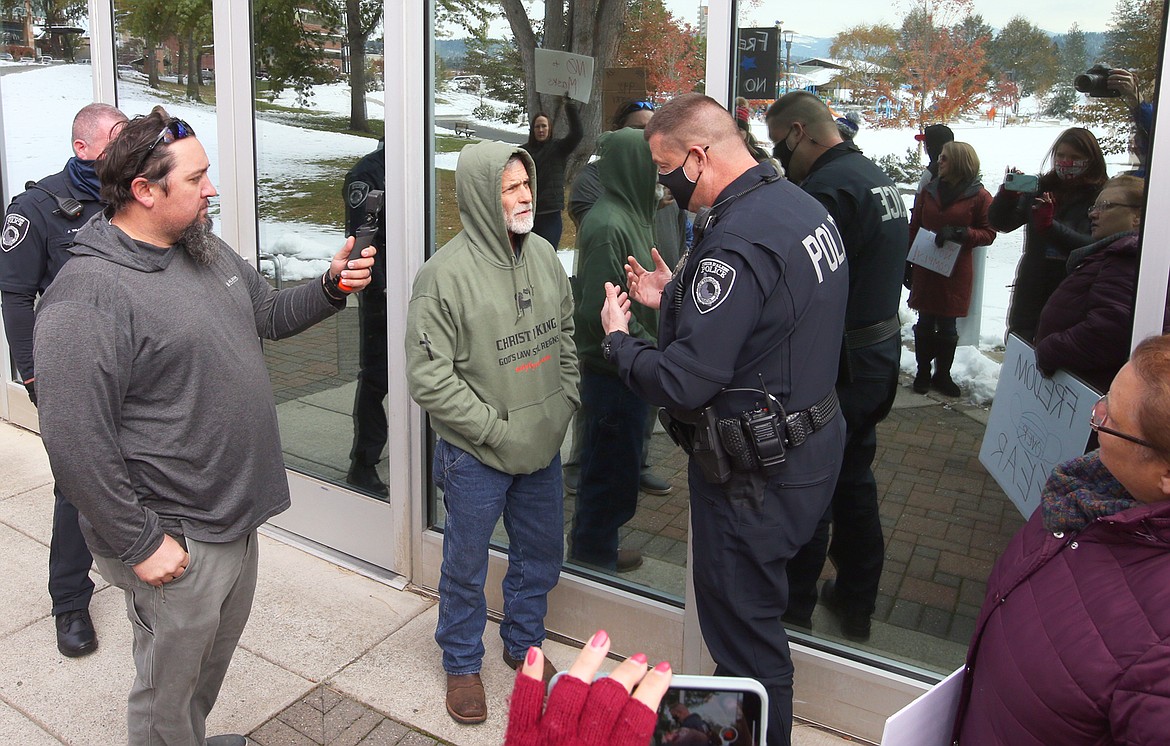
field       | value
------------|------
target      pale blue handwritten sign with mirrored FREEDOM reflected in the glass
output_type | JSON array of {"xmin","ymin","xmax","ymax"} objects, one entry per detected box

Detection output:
[{"xmin": 979, "ymin": 334, "xmax": 1099, "ymax": 518}]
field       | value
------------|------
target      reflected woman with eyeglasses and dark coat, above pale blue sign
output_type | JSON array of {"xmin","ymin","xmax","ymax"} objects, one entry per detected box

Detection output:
[{"xmin": 1035, "ymin": 175, "xmax": 1160, "ymax": 391}]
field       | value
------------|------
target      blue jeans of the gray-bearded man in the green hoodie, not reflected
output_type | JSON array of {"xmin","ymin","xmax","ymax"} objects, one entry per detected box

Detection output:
[{"xmin": 432, "ymin": 440, "xmax": 565, "ymax": 676}]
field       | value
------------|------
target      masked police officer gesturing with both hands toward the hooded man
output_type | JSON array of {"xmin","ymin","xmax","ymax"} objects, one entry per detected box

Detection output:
[{"xmin": 601, "ymin": 94, "xmax": 848, "ymax": 746}]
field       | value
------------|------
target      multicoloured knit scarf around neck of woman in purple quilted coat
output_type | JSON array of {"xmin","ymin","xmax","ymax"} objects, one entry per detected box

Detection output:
[{"xmin": 1040, "ymin": 450, "xmax": 1137, "ymax": 533}]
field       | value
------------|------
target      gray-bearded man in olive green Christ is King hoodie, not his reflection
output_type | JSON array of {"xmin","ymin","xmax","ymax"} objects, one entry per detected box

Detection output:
[{"xmin": 405, "ymin": 141, "xmax": 579, "ymax": 724}]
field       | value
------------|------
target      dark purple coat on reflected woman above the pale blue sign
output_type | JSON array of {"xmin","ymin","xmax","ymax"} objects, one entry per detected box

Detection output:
[{"xmin": 1035, "ymin": 233, "xmax": 1137, "ymax": 392}]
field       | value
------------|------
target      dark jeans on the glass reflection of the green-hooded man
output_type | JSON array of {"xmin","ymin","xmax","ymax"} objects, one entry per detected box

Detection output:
[{"xmin": 572, "ymin": 371, "xmax": 646, "ymax": 569}]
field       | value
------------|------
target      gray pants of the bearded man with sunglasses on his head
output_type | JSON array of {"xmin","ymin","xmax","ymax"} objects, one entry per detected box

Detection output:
[{"xmin": 94, "ymin": 531, "xmax": 260, "ymax": 746}]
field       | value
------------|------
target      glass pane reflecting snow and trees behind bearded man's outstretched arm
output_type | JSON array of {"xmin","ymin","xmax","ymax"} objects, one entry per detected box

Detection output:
[{"xmin": 252, "ymin": 0, "xmax": 387, "ymax": 499}]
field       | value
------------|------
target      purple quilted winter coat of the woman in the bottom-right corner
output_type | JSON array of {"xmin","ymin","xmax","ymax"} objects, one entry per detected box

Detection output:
[{"xmin": 955, "ymin": 481, "xmax": 1170, "ymax": 746}]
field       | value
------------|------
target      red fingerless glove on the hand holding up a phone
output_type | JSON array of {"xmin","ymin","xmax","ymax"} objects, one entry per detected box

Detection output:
[{"xmin": 504, "ymin": 674, "xmax": 658, "ymax": 746}]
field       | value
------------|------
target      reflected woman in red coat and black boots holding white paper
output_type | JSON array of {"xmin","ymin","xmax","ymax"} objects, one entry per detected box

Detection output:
[{"xmin": 909, "ymin": 143, "xmax": 996, "ymax": 396}]
